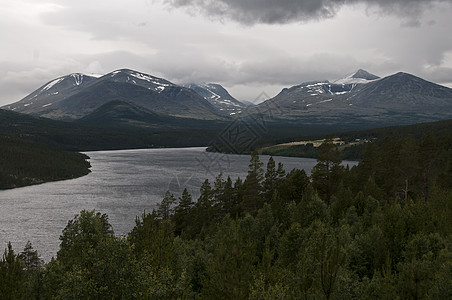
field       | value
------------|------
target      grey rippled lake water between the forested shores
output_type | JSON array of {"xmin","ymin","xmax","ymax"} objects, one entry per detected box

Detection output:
[{"xmin": 0, "ymin": 148, "xmax": 356, "ymax": 261}]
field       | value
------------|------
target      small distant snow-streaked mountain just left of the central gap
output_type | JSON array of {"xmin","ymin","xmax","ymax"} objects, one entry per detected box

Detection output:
[{"xmin": 184, "ymin": 83, "xmax": 246, "ymax": 116}]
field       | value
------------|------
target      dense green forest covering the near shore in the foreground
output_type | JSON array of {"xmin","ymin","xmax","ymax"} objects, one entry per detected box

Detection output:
[{"xmin": 0, "ymin": 132, "xmax": 452, "ymax": 299}]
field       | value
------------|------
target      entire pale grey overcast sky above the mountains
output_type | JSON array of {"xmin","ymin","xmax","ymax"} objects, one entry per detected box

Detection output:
[{"xmin": 0, "ymin": 0, "xmax": 452, "ymax": 105}]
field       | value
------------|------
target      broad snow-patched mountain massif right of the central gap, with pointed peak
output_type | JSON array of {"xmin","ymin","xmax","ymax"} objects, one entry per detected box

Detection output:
[{"xmin": 250, "ymin": 70, "xmax": 452, "ymax": 129}]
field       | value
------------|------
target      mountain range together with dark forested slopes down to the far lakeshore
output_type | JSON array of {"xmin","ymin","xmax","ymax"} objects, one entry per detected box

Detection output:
[{"xmin": 0, "ymin": 69, "xmax": 452, "ymax": 153}]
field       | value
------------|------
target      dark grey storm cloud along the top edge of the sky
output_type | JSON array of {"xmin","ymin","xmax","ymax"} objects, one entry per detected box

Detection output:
[{"xmin": 165, "ymin": 0, "xmax": 452, "ymax": 25}]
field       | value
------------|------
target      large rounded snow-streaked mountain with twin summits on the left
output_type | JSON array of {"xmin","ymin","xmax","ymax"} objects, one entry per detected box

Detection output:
[{"xmin": 4, "ymin": 69, "xmax": 224, "ymax": 120}]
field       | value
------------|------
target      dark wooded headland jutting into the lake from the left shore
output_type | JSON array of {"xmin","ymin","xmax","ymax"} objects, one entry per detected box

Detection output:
[{"xmin": 0, "ymin": 134, "xmax": 90, "ymax": 189}]
